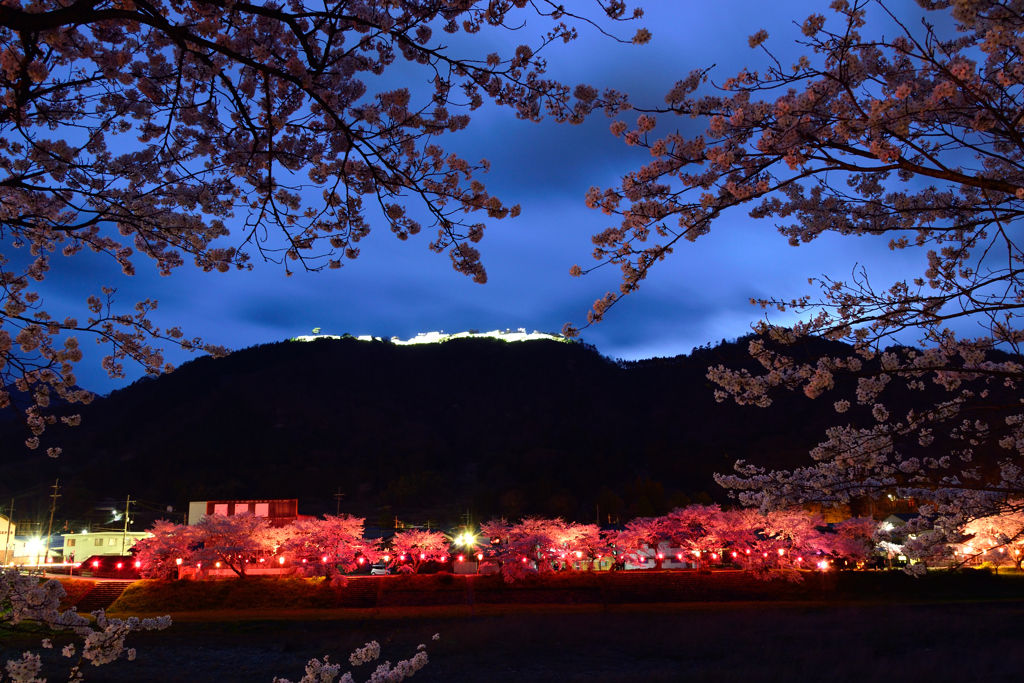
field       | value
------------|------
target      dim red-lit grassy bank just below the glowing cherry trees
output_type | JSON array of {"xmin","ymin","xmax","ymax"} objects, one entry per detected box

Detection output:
[{"xmin": 101, "ymin": 570, "xmax": 1024, "ymax": 615}]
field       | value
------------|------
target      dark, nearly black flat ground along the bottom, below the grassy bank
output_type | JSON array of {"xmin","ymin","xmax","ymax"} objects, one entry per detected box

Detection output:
[{"xmin": 8, "ymin": 601, "xmax": 1024, "ymax": 683}]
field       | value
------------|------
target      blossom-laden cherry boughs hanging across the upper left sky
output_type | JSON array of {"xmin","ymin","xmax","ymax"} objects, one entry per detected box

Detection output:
[{"xmin": 0, "ymin": 0, "xmax": 650, "ymax": 456}]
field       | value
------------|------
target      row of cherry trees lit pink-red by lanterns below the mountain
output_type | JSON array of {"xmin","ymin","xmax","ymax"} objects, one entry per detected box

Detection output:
[{"xmin": 134, "ymin": 505, "xmax": 1024, "ymax": 582}]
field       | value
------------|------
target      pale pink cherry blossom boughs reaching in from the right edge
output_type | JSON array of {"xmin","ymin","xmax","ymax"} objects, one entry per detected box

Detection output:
[{"xmin": 565, "ymin": 0, "xmax": 1024, "ymax": 565}]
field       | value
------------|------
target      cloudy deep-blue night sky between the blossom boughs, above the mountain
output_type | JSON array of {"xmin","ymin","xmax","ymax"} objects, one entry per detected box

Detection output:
[{"xmin": 29, "ymin": 0, "xmax": 924, "ymax": 393}]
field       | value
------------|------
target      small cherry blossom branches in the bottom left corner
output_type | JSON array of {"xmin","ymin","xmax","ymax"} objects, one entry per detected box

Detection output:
[{"xmin": 0, "ymin": 569, "xmax": 171, "ymax": 683}]
